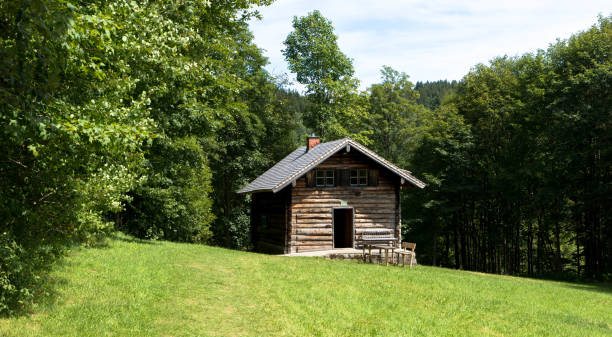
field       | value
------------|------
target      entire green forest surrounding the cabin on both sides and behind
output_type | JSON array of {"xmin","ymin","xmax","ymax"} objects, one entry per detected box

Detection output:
[{"xmin": 0, "ymin": 0, "xmax": 612, "ymax": 313}]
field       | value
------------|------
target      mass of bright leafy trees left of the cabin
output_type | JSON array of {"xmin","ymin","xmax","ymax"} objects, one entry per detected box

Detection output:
[{"xmin": 0, "ymin": 0, "xmax": 296, "ymax": 313}]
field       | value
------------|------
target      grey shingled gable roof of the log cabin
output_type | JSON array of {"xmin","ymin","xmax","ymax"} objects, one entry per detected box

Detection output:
[{"xmin": 238, "ymin": 138, "xmax": 425, "ymax": 193}]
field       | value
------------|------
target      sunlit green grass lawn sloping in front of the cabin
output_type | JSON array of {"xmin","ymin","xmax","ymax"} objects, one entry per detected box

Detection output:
[{"xmin": 0, "ymin": 235, "xmax": 612, "ymax": 336}]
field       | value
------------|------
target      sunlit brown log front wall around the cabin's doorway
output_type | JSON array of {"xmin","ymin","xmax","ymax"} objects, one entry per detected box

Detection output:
[{"xmin": 289, "ymin": 150, "xmax": 401, "ymax": 252}]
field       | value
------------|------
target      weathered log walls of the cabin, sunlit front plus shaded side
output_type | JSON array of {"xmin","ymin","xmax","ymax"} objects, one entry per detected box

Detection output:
[{"xmin": 251, "ymin": 147, "xmax": 401, "ymax": 252}]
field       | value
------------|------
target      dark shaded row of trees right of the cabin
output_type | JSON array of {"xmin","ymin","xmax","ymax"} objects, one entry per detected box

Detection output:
[{"xmin": 404, "ymin": 17, "xmax": 612, "ymax": 279}]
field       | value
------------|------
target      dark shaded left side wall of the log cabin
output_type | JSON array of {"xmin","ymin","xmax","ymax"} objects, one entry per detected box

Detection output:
[{"xmin": 251, "ymin": 189, "xmax": 290, "ymax": 254}]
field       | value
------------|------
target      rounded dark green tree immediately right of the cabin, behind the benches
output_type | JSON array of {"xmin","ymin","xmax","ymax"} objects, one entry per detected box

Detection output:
[{"xmin": 402, "ymin": 104, "xmax": 474, "ymax": 268}]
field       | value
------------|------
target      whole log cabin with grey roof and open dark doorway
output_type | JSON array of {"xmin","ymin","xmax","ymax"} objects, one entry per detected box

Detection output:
[{"xmin": 238, "ymin": 136, "xmax": 425, "ymax": 254}]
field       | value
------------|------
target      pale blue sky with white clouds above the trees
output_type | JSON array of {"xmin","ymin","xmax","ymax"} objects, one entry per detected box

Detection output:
[{"xmin": 250, "ymin": 0, "xmax": 612, "ymax": 90}]
